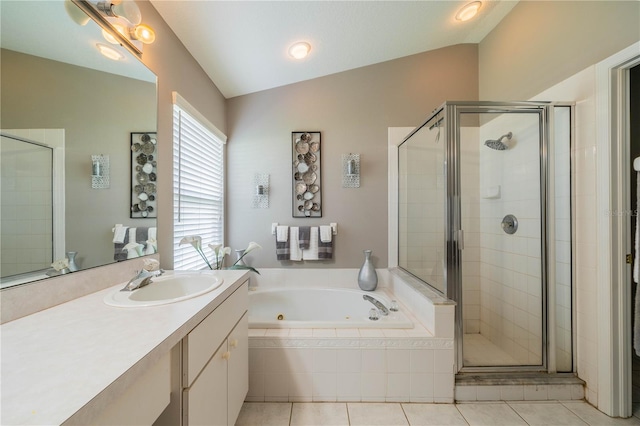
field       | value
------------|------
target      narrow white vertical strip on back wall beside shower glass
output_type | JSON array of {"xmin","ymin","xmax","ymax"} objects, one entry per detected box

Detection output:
[{"xmin": 387, "ymin": 127, "xmax": 414, "ymax": 268}]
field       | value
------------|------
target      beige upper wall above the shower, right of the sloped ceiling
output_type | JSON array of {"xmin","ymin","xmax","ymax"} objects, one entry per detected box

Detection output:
[{"xmin": 478, "ymin": 1, "xmax": 640, "ymax": 101}]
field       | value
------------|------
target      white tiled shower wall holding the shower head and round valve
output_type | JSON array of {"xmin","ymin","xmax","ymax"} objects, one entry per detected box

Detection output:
[{"xmin": 479, "ymin": 114, "xmax": 542, "ymax": 365}]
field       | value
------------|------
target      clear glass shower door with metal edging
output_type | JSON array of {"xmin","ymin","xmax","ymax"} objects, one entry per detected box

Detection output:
[{"xmin": 456, "ymin": 107, "xmax": 546, "ymax": 369}]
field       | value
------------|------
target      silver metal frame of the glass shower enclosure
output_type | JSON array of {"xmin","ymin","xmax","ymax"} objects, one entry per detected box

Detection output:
[{"xmin": 400, "ymin": 101, "xmax": 576, "ymax": 373}]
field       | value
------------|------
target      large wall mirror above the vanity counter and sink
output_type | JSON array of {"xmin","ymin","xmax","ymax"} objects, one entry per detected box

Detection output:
[{"xmin": 0, "ymin": 0, "xmax": 157, "ymax": 288}]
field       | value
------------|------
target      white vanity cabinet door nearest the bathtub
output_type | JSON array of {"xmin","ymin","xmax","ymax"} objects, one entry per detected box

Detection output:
[{"xmin": 227, "ymin": 313, "xmax": 249, "ymax": 425}]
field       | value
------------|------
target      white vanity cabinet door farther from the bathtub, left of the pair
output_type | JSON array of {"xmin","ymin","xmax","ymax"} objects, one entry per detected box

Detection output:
[{"xmin": 183, "ymin": 341, "xmax": 229, "ymax": 426}]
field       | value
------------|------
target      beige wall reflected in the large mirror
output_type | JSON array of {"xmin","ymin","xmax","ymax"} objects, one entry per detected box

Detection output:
[{"xmin": 0, "ymin": 50, "xmax": 156, "ymax": 268}]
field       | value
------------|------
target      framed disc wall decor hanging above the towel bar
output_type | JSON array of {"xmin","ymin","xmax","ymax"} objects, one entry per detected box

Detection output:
[{"xmin": 291, "ymin": 131, "xmax": 322, "ymax": 217}]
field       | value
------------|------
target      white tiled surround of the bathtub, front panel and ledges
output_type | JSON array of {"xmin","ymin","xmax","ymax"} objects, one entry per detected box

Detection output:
[{"xmin": 246, "ymin": 269, "xmax": 454, "ymax": 403}]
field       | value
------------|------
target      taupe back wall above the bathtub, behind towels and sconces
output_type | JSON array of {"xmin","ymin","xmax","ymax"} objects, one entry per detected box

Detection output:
[{"xmin": 227, "ymin": 44, "xmax": 478, "ymax": 268}]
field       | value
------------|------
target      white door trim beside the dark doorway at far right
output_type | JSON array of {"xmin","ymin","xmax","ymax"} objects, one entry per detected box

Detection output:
[{"xmin": 596, "ymin": 42, "xmax": 640, "ymax": 417}]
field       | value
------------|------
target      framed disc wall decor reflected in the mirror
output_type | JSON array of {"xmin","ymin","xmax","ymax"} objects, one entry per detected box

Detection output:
[{"xmin": 131, "ymin": 132, "xmax": 158, "ymax": 219}]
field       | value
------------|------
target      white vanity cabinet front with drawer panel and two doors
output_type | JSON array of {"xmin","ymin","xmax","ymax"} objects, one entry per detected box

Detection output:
[{"xmin": 182, "ymin": 282, "xmax": 249, "ymax": 425}]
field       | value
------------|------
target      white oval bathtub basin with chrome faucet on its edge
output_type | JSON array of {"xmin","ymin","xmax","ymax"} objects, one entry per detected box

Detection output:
[{"xmin": 249, "ymin": 287, "xmax": 413, "ymax": 328}]
